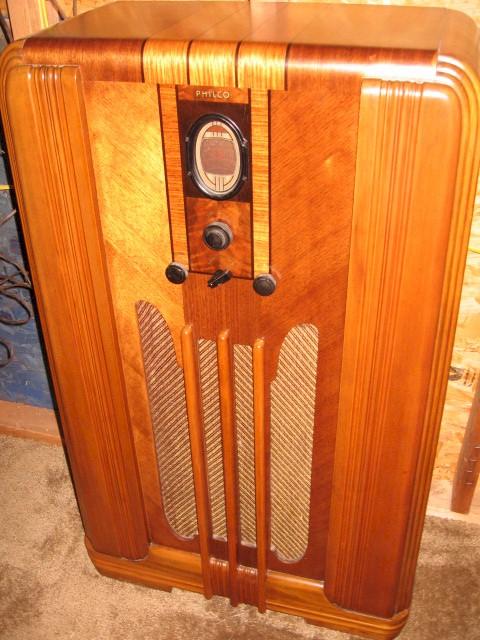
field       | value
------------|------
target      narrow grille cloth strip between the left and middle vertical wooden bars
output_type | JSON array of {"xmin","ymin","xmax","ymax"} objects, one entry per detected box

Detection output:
[{"xmin": 198, "ymin": 339, "xmax": 227, "ymax": 539}]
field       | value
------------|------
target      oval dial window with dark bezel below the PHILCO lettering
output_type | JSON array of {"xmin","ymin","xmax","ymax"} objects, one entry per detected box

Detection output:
[{"xmin": 190, "ymin": 115, "xmax": 243, "ymax": 198}]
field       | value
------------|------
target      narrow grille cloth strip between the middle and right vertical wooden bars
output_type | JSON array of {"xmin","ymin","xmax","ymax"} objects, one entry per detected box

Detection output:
[{"xmin": 233, "ymin": 344, "xmax": 256, "ymax": 546}]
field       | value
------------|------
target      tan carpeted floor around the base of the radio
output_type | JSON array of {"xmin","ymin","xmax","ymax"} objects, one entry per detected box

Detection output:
[{"xmin": 0, "ymin": 436, "xmax": 480, "ymax": 640}]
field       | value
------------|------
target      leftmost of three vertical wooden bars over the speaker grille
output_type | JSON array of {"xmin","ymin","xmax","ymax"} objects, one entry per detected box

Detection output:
[{"xmin": 182, "ymin": 325, "xmax": 213, "ymax": 598}]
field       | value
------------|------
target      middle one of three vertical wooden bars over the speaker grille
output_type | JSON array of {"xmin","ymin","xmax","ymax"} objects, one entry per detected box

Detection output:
[{"xmin": 217, "ymin": 330, "xmax": 239, "ymax": 605}]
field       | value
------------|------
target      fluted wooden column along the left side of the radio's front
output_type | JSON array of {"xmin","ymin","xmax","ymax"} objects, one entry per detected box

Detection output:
[{"xmin": 1, "ymin": 60, "xmax": 147, "ymax": 558}]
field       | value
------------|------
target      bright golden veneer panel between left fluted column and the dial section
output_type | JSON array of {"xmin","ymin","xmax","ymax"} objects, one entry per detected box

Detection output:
[{"xmin": 80, "ymin": 82, "xmax": 189, "ymax": 550}]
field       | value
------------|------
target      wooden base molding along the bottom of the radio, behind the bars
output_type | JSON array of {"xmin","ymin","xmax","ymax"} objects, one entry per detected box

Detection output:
[{"xmin": 86, "ymin": 539, "xmax": 408, "ymax": 640}]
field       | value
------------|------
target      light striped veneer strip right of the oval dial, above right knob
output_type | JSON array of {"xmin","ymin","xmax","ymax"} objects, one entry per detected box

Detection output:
[{"xmin": 250, "ymin": 89, "xmax": 270, "ymax": 276}]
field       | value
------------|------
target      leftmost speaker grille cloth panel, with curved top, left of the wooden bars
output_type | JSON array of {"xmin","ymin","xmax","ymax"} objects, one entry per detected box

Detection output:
[{"xmin": 136, "ymin": 301, "xmax": 197, "ymax": 538}]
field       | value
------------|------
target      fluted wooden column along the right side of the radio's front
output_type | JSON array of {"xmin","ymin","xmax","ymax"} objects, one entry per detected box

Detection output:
[{"xmin": 326, "ymin": 80, "xmax": 461, "ymax": 617}]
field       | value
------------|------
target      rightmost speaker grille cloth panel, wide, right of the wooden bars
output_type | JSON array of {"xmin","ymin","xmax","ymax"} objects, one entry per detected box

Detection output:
[{"xmin": 270, "ymin": 324, "xmax": 318, "ymax": 561}]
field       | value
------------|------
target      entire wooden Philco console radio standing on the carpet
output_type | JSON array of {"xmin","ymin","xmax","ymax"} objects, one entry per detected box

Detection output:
[{"xmin": 1, "ymin": 2, "xmax": 480, "ymax": 638}]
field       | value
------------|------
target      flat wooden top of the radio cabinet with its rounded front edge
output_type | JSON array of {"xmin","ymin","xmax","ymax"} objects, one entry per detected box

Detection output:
[{"xmin": 15, "ymin": 0, "xmax": 480, "ymax": 79}]
